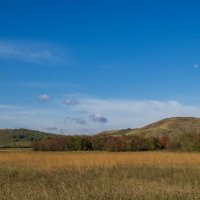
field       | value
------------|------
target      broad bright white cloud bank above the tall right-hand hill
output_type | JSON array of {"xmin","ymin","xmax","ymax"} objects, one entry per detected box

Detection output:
[{"xmin": 62, "ymin": 96, "xmax": 200, "ymax": 132}]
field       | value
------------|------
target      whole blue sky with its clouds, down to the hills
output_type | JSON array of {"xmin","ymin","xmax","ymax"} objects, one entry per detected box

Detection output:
[{"xmin": 0, "ymin": 0, "xmax": 200, "ymax": 134}]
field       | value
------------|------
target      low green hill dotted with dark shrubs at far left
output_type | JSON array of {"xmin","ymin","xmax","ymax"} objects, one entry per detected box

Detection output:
[{"xmin": 0, "ymin": 129, "xmax": 55, "ymax": 147}]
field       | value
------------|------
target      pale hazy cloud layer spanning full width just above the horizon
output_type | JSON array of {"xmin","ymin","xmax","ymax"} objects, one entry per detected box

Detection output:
[{"xmin": 0, "ymin": 95, "xmax": 200, "ymax": 134}]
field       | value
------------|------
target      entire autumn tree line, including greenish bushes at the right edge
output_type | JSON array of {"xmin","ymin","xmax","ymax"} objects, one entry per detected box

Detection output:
[{"xmin": 31, "ymin": 130, "xmax": 200, "ymax": 152}]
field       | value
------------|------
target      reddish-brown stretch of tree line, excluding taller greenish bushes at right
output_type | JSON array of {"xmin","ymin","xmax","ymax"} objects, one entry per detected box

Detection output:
[{"xmin": 31, "ymin": 136, "xmax": 168, "ymax": 152}]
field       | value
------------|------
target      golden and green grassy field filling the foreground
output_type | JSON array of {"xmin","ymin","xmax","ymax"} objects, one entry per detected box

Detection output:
[{"xmin": 0, "ymin": 150, "xmax": 200, "ymax": 200}]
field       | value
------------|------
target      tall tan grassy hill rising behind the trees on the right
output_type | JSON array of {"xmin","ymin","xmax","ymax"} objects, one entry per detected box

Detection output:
[{"xmin": 97, "ymin": 117, "xmax": 200, "ymax": 137}]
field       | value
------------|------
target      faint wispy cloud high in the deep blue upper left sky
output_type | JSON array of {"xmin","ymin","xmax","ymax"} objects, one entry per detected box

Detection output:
[{"xmin": 0, "ymin": 40, "xmax": 64, "ymax": 65}]
